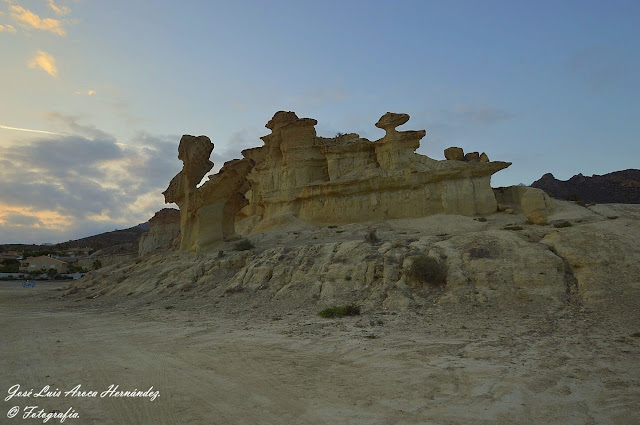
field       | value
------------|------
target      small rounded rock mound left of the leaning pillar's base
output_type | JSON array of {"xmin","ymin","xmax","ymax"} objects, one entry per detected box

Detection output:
[{"xmin": 138, "ymin": 208, "xmax": 180, "ymax": 256}]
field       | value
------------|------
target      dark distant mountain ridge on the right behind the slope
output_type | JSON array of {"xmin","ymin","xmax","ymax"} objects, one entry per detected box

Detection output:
[{"xmin": 531, "ymin": 169, "xmax": 640, "ymax": 204}]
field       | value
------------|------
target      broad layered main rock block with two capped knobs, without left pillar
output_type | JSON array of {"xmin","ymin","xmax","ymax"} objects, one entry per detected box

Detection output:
[{"xmin": 242, "ymin": 111, "xmax": 510, "ymax": 229}]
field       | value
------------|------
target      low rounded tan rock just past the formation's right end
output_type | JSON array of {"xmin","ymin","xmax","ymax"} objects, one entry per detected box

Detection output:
[{"xmin": 494, "ymin": 186, "xmax": 553, "ymax": 224}]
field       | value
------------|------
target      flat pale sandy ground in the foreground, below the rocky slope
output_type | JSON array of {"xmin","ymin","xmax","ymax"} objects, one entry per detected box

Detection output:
[{"xmin": 0, "ymin": 282, "xmax": 640, "ymax": 425}]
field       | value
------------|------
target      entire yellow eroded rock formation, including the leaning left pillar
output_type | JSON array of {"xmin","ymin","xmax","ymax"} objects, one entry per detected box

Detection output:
[{"xmin": 164, "ymin": 111, "xmax": 510, "ymax": 251}]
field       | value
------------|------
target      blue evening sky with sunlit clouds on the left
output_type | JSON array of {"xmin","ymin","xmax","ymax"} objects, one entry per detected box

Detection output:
[{"xmin": 0, "ymin": 0, "xmax": 640, "ymax": 243}]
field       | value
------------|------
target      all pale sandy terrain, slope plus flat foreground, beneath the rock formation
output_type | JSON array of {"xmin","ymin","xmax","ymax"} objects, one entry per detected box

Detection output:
[{"xmin": 0, "ymin": 203, "xmax": 640, "ymax": 425}]
